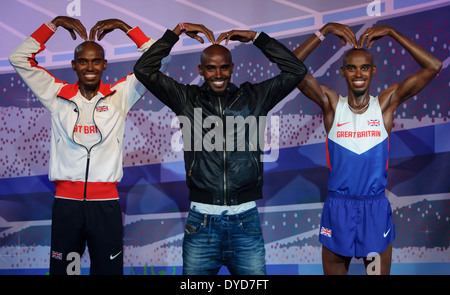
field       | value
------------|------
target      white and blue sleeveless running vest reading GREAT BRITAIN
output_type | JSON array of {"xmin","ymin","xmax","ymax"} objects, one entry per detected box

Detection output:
[{"xmin": 326, "ymin": 96, "xmax": 389, "ymax": 196}]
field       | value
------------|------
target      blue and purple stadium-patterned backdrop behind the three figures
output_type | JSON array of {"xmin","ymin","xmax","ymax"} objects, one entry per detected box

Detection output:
[{"xmin": 0, "ymin": 0, "xmax": 450, "ymax": 275}]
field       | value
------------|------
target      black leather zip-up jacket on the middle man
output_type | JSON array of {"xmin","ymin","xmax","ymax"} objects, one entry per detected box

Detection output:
[{"xmin": 134, "ymin": 30, "xmax": 307, "ymax": 205}]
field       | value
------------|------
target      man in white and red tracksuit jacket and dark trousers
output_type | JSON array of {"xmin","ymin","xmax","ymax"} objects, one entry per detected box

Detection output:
[{"xmin": 9, "ymin": 16, "xmax": 154, "ymax": 274}]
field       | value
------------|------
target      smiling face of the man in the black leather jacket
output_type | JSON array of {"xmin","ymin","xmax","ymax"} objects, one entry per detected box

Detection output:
[{"xmin": 198, "ymin": 44, "xmax": 234, "ymax": 93}]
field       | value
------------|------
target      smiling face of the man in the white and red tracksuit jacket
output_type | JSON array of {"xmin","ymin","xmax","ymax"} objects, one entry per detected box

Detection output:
[{"xmin": 72, "ymin": 42, "xmax": 107, "ymax": 91}]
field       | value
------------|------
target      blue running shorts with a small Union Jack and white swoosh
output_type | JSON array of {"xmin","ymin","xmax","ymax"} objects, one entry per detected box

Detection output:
[{"xmin": 319, "ymin": 192, "xmax": 395, "ymax": 258}]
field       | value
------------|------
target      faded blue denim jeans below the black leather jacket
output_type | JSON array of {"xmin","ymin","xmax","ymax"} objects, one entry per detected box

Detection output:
[{"xmin": 183, "ymin": 207, "xmax": 266, "ymax": 275}]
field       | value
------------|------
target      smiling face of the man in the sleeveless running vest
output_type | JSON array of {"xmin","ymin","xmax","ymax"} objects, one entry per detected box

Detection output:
[{"xmin": 341, "ymin": 49, "xmax": 376, "ymax": 97}]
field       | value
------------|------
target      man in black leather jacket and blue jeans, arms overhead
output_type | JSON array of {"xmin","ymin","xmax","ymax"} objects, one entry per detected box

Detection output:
[{"xmin": 134, "ymin": 23, "xmax": 307, "ymax": 274}]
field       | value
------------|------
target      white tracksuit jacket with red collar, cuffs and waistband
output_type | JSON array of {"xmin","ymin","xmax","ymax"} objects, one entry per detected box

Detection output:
[{"xmin": 9, "ymin": 24, "xmax": 154, "ymax": 200}]
